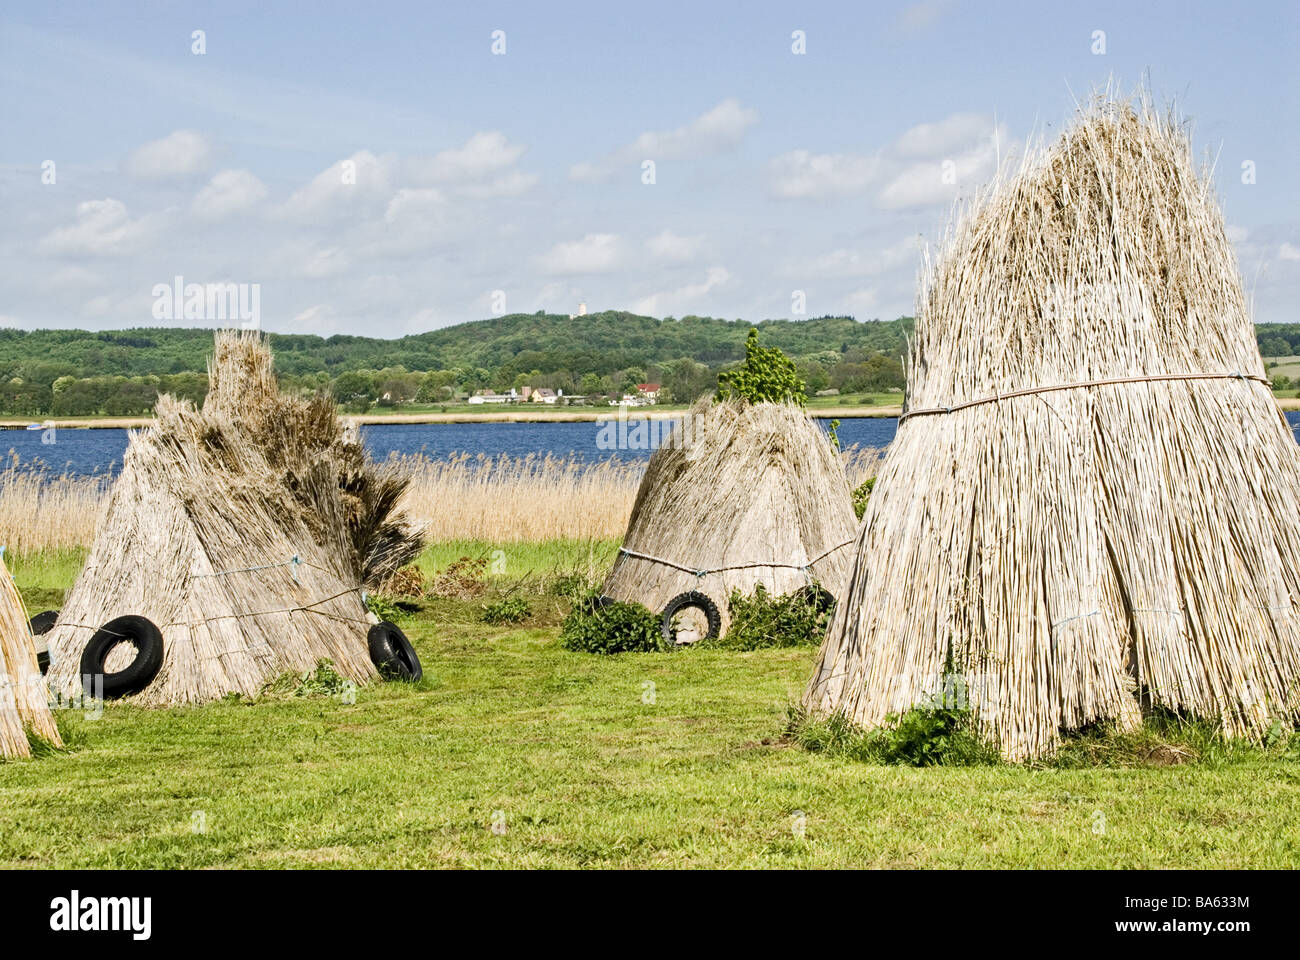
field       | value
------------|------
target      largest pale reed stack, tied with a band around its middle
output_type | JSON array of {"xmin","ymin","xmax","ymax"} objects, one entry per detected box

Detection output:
[{"xmin": 805, "ymin": 98, "xmax": 1300, "ymax": 760}]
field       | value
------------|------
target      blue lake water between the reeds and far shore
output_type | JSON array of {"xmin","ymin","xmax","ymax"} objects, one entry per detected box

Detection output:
[{"xmin": 0, "ymin": 411, "xmax": 1300, "ymax": 475}]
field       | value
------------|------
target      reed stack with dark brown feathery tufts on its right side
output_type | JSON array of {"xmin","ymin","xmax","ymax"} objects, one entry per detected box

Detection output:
[{"xmin": 48, "ymin": 330, "xmax": 420, "ymax": 705}]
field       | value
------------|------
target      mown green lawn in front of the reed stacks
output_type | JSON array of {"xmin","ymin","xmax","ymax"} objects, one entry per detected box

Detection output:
[{"xmin": 0, "ymin": 549, "xmax": 1300, "ymax": 868}]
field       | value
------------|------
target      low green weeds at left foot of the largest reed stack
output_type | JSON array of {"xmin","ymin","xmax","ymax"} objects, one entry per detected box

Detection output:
[{"xmin": 788, "ymin": 706, "xmax": 1001, "ymax": 766}]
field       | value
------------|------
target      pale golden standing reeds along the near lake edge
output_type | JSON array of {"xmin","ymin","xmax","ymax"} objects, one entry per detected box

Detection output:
[{"xmin": 0, "ymin": 447, "xmax": 881, "ymax": 554}]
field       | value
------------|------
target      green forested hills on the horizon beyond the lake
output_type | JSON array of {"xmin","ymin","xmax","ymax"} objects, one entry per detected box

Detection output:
[{"xmin": 0, "ymin": 311, "xmax": 1300, "ymax": 416}]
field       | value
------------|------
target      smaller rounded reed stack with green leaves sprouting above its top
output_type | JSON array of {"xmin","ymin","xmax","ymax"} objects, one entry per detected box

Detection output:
[{"xmin": 605, "ymin": 398, "xmax": 857, "ymax": 631}]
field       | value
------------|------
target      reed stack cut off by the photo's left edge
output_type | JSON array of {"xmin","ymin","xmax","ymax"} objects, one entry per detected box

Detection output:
[{"xmin": 0, "ymin": 550, "xmax": 62, "ymax": 757}]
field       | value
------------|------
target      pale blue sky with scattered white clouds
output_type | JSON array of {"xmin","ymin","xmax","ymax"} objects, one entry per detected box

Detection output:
[{"xmin": 0, "ymin": 1, "xmax": 1300, "ymax": 337}]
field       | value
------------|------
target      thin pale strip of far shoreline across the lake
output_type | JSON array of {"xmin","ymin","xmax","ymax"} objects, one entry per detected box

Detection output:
[{"xmin": 0, "ymin": 397, "xmax": 1300, "ymax": 429}]
